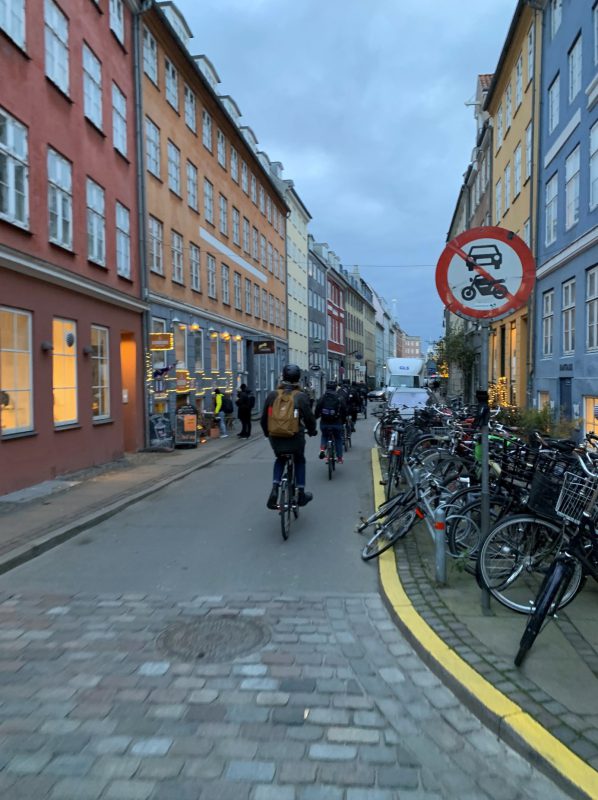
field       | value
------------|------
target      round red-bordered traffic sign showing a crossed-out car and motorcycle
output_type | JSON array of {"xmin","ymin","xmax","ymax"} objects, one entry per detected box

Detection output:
[{"xmin": 436, "ymin": 226, "xmax": 536, "ymax": 319}]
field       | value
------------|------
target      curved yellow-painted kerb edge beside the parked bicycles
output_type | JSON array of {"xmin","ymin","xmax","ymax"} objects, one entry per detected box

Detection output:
[{"xmin": 372, "ymin": 448, "xmax": 598, "ymax": 800}]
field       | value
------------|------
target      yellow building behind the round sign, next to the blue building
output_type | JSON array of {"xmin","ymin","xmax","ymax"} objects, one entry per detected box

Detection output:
[{"xmin": 484, "ymin": 0, "xmax": 542, "ymax": 407}]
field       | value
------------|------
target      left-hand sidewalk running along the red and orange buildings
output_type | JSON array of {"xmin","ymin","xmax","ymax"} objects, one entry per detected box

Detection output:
[{"xmin": 0, "ymin": 430, "xmax": 255, "ymax": 573}]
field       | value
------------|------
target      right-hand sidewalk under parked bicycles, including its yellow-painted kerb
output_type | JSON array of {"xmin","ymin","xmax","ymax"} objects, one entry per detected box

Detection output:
[{"xmin": 372, "ymin": 450, "xmax": 598, "ymax": 800}]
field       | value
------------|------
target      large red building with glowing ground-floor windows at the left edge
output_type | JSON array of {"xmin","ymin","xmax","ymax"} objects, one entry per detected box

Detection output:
[{"xmin": 0, "ymin": 0, "xmax": 145, "ymax": 494}]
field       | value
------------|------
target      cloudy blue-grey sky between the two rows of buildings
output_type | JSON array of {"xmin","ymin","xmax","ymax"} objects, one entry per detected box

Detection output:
[{"xmin": 175, "ymin": 0, "xmax": 516, "ymax": 347}]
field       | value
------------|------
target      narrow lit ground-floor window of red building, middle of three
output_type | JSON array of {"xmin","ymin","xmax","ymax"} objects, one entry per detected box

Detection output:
[{"xmin": 52, "ymin": 318, "xmax": 78, "ymax": 426}]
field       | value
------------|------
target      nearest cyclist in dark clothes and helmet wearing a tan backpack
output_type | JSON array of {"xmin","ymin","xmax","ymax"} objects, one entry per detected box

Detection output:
[{"xmin": 260, "ymin": 364, "xmax": 318, "ymax": 509}]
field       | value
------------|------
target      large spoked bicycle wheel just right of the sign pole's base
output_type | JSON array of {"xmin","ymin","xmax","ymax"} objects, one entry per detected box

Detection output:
[{"xmin": 476, "ymin": 514, "xmax": 574, "ymax": 614}]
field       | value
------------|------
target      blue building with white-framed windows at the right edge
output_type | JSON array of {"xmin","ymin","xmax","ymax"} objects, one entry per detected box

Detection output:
[{"xmin": 533, "ymin": 0, "xmax": 598, "ymax": 432}]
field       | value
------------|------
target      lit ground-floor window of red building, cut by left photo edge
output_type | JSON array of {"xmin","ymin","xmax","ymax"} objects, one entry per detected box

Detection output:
[{"xmin": 0, "ymin": 306, "xmax": 33, "ymax": 434}]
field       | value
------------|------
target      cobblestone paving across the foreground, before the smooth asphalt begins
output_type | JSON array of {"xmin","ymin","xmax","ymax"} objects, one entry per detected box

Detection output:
[{"xmin": 0, "ymin": 592, "xmax": 566, "ymax": 800}]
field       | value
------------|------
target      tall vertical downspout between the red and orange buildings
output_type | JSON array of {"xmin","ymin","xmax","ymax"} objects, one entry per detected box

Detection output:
[{"xmin": 133, "ymin": 0, "xmax": 152, "ymax": 448}]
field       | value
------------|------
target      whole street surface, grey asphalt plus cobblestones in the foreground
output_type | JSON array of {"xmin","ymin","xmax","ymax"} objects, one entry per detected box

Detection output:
[{"xmin": 0, "ymin": 420, "xmax": 566, "ymax": 800}]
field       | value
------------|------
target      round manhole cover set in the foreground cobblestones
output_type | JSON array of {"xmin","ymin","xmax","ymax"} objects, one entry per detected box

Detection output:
[{"xmin": 157, "ymin": 617, "xmax": 270, "ymax": 662}]
